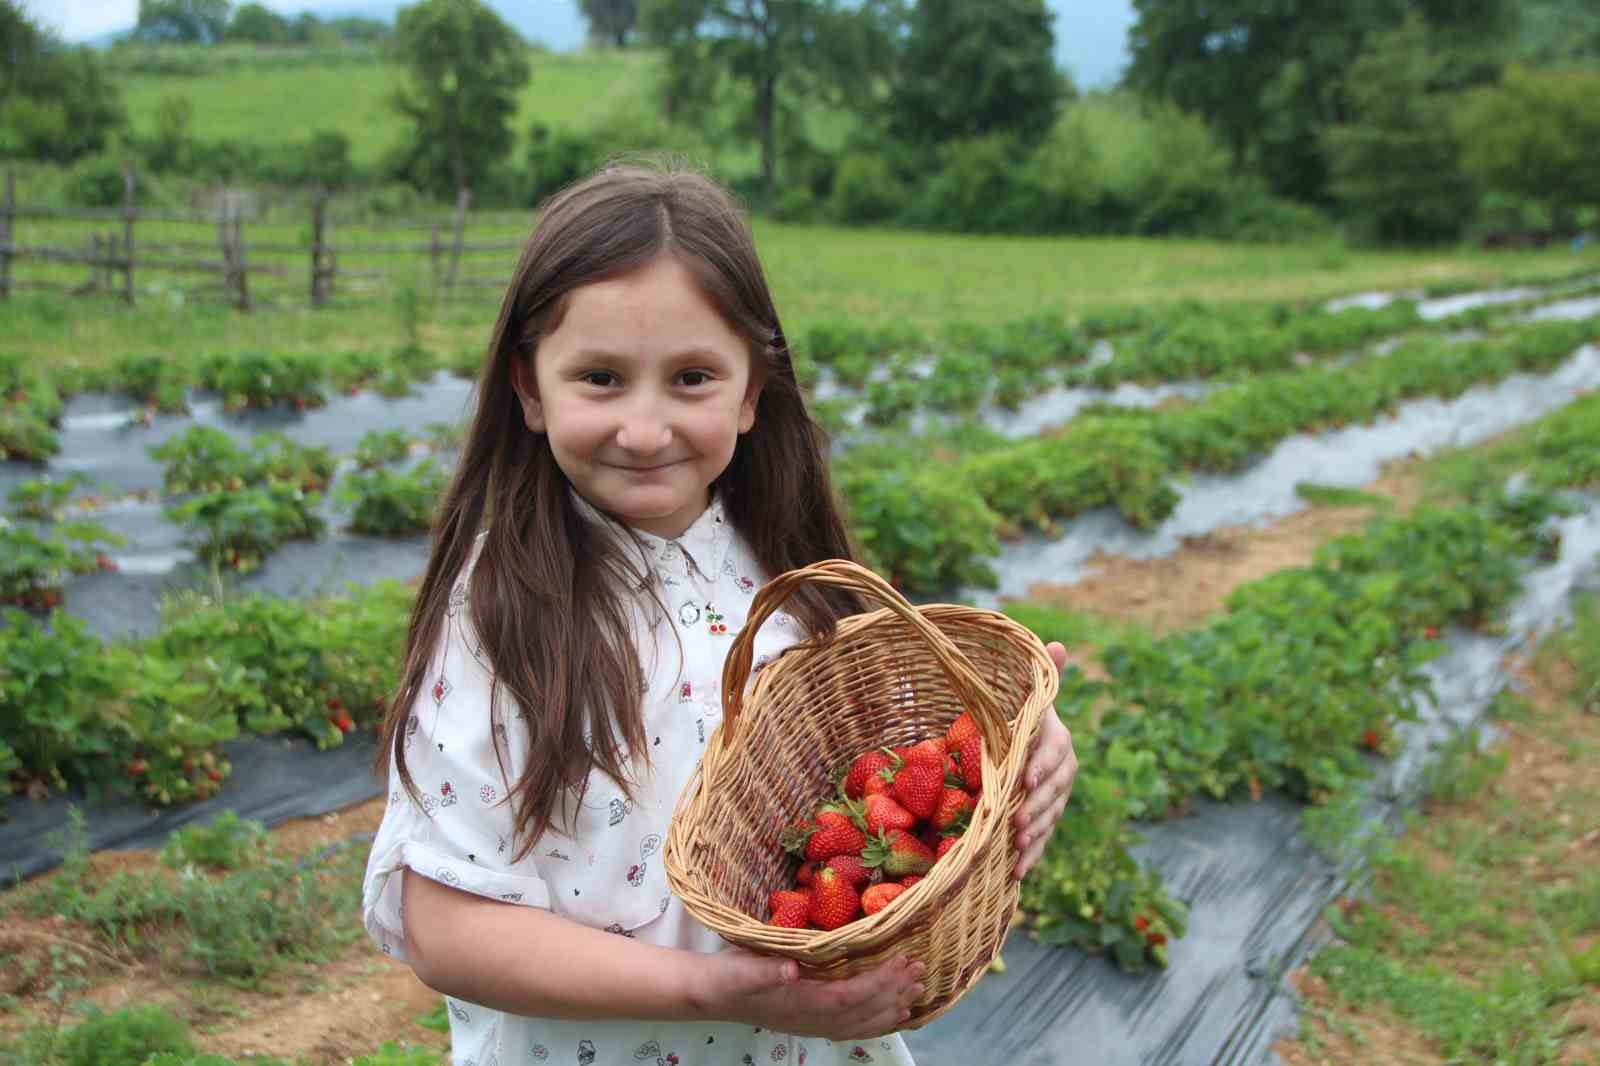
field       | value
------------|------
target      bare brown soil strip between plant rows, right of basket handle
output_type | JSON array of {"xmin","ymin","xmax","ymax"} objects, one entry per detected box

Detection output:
[{"xmin": 1027, "ymin": 463, "xmax": 1422, "ymax": 634}]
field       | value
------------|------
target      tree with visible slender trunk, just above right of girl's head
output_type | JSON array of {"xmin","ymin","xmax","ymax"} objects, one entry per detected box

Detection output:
[{"xmin": 640, "ymin": 0, "xmax": 888, "ymax": 202}]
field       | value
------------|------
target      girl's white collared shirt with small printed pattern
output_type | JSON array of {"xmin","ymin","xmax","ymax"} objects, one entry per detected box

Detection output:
[{"xmin": 362, "ymin": 493, "xmax": 912, "ymax": 1066}]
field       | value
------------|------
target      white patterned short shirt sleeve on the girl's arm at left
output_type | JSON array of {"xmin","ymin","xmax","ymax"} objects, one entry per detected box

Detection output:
[{"xmin": 362, "ymin": 579, "xmax": 550, "ymax": 959}]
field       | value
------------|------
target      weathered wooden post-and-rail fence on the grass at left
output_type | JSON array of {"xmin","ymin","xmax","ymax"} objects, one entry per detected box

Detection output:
[{"xmin": 0, "ymin": 170, "xmax": 523, "ymax": 311}]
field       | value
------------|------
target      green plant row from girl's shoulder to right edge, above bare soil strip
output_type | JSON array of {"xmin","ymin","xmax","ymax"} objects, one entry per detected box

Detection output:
[{"xmin": 837, "ymin": 319, "xmax": 1600, "ymax": 592}]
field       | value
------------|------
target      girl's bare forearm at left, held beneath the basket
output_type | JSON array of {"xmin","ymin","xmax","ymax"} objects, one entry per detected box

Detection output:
[{"xmin": 402, "ymin": 869, "xmax": 712, "ymax": 1021}]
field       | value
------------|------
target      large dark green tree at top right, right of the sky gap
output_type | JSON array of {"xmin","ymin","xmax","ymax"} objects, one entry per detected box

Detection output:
[{"xmin": 1126, "ymin": 0, "xmax": 1517, "ymax": 202}]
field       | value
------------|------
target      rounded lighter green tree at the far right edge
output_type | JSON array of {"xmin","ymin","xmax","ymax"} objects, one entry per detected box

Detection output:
[{"xmin": 1454, "ymin": 64, "xmax": 1600, "ymax": 230}]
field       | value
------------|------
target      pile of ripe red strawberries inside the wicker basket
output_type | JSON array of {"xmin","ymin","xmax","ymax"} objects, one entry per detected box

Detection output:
[{"xmin": 768, "ymin": 712, "xmax": 984, "ymax": 930}]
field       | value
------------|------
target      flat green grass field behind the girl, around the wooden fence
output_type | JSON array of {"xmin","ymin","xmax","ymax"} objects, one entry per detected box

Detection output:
[{"xmin": 0, "ymin": 216, "xmax": 1600, "ymax": 376}]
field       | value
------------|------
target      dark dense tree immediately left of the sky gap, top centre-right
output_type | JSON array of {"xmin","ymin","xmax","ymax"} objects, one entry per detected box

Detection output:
[{"xmin": 888, "ymin": 0, "xmax": 1070, "ymax": 147}]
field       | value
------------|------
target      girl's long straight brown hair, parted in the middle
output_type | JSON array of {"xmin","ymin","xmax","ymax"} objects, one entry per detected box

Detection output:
[{"xmin": 376, "ymin": 163, "xmax": 861, "ymax": 860}]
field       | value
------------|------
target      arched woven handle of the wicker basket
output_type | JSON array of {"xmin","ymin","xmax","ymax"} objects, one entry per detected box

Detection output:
[{"xmin": 722, "ymin": 559, "xmax": 1011, "ymax": 762}]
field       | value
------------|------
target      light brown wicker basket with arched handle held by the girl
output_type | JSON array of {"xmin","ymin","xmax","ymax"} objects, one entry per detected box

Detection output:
[{"xmin": 664, "ymin": 559, "xmax": 1058, "ymax": 1029}]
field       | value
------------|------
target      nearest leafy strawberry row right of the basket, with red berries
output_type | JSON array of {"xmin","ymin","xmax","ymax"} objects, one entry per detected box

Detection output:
[{"xmin": 1008, "ymin": 390, "xmax": 1600, "ymax": 970}]
